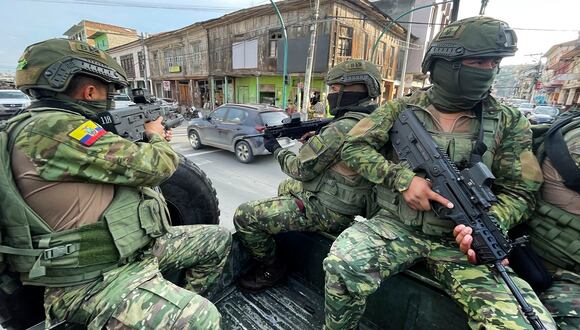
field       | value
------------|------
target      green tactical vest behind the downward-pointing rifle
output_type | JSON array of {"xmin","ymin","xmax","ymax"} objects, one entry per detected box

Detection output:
[{"xmin": 374, "ymin": 104, "xmax": 501, "ymax": 236}]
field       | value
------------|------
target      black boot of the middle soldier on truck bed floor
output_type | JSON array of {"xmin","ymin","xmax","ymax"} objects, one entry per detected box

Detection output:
[{"xmin": 238, "ymin": 258, "xmax": 288, "ymax": 292}]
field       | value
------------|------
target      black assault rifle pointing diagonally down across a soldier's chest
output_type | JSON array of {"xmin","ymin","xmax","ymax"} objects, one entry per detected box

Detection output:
[{"xmin": 389, "ymin": 108, "xmax": 545, "ymax": 329}]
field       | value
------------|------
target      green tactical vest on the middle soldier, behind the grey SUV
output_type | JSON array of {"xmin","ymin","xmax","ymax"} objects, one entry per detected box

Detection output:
[{"xmin": 302, "ymin": 111, "xmax": 372, "ymax": 215}]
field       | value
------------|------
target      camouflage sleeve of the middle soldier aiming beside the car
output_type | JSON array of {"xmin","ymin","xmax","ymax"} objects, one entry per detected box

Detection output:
[{"xmin": 274, "ymin": 119, "xmax": 356, "ymax": 181}]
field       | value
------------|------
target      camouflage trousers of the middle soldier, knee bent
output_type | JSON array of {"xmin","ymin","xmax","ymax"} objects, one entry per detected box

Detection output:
[{"xmin": 234, "ymin": 180, "xmax": 354, "ymax": 262}]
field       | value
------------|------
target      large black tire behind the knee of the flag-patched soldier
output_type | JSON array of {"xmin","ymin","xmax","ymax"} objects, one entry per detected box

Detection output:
[{"xmin": 161, "ymin": 155, "xmax": 220, "ymax": 226}]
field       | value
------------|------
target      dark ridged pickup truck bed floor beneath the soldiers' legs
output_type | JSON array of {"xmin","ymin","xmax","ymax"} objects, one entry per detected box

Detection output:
[{"xmin": 212, "ymin": 233, "xmax": 467, "ymax": 330}]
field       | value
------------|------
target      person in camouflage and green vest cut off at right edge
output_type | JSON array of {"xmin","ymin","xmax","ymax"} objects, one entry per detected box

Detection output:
[{"xmin": 458, "ymin": 110, "xmax": 580, "ymax": 329}]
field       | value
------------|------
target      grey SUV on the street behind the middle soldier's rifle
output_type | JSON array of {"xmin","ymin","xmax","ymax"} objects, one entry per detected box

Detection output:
[{"xmin": 187, "ymin": 104, "xmax": 293, "ymax": 163}]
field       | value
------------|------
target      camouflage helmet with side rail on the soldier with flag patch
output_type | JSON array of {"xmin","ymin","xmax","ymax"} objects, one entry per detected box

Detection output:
[{"xmin": 15, "ymin": 39, "xmax": 128, "ymax": 95}]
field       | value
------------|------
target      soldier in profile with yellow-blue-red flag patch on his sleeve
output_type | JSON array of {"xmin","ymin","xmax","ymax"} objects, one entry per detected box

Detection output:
[{"xmin": 0, "ymin": 39, "xmax": 231, "ymax": 329}]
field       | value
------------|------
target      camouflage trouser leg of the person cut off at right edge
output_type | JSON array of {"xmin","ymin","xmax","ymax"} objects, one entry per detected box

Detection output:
[{"xmin": 540, "ymin": 269, "xmax": 580, "ymax": 329}]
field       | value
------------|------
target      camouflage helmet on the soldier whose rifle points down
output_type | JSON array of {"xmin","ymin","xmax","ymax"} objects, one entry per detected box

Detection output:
[{"xmin": 421, "ymin": 16, "xmax": 518, "ymax": 73}]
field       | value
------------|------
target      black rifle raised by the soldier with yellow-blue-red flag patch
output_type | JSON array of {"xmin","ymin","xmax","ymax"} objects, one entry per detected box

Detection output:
[{"xmin": 96, "ymin": 88, "xmax": 183, "ymax": 141}]
